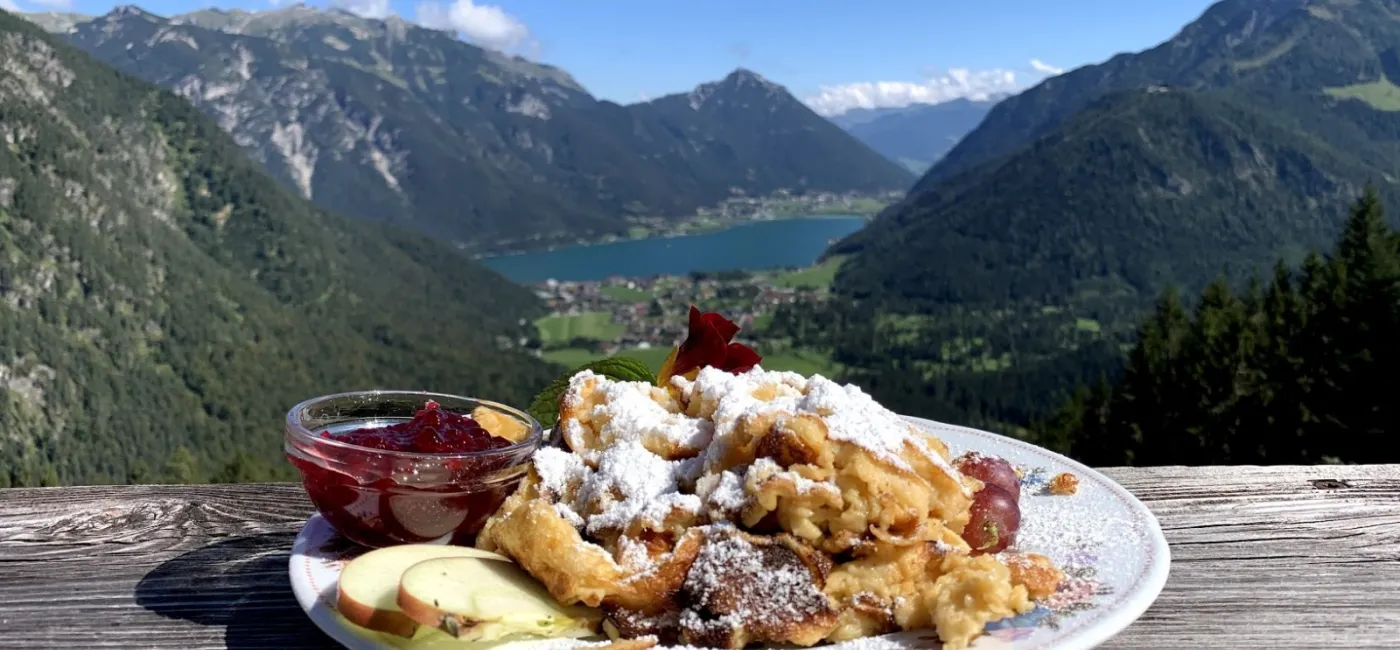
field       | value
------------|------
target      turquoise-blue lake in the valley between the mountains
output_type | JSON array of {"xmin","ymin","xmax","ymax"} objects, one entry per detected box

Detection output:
[{"xmin": 480, "ymin": 216, "xmax": 865, "ymax": 284}]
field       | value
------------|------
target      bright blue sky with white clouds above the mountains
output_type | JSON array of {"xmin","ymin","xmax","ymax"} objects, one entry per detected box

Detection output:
[{"xmin": 8, "ymin": 0, "xmax": 1211, "ymax": 113}]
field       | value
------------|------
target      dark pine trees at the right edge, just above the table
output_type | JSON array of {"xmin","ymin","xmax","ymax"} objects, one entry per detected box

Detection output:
[{"xmin": 1036, "ymin": 188, "xmax": 1400, "ymax": 465}]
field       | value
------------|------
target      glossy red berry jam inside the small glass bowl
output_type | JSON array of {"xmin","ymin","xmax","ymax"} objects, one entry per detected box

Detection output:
[{"xmin": 288, "ymin": 402, "xmax": 525, "ymax": 548}]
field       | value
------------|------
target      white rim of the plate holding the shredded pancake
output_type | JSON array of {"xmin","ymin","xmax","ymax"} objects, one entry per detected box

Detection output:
[{"xmin": 287, "ymin": 416, "xmax": 1172, "ymax": 650}]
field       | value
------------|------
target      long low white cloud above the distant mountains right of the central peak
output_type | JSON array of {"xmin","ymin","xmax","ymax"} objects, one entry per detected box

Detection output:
[{"xmin": 805, "ymin": 67, "xmax": 1025, "ymax": 115}]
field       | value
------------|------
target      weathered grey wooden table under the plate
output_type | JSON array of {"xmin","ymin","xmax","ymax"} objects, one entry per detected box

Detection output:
[{"xmin": 0, "ymin": 465, "xmax": 1400, "ymax": 650}]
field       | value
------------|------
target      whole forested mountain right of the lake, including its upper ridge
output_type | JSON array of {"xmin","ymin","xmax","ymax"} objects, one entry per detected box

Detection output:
[{"xmin": 833, "ymin": 0, "xmax": 1400, "ymax": 315}]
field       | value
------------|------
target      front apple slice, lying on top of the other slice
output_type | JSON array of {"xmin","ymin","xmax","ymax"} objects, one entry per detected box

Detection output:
[{"xmin": 399, "ymin": 558, "xmax": 602, "ymax": 642}]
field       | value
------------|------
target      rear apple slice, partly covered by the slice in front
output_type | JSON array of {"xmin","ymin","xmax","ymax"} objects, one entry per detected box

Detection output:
[{"xmin": 336, "ymin": 544, "xmax": 510, "ymax": 637}]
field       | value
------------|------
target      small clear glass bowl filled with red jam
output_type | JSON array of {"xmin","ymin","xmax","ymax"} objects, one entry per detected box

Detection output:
[{"xmin": 286, "ymin": 391, "xmax": 543, "ymax": 548}]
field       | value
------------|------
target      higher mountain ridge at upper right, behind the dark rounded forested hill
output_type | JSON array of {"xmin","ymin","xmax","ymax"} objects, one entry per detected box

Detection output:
[{"xmin": 918, "ymin": 0, "xmax": 1400, "ymax": 188}]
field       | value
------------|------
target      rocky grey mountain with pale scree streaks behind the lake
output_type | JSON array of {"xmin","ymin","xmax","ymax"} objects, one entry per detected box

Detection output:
[{"xmin": 40, "ymin": 6, "xmax": 913, "ymax": 249}]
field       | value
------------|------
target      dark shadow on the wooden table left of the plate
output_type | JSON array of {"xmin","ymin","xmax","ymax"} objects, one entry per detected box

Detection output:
[{"xmin": 136, "ymin": 532, "xmax": 339, "ymax": 650}]
